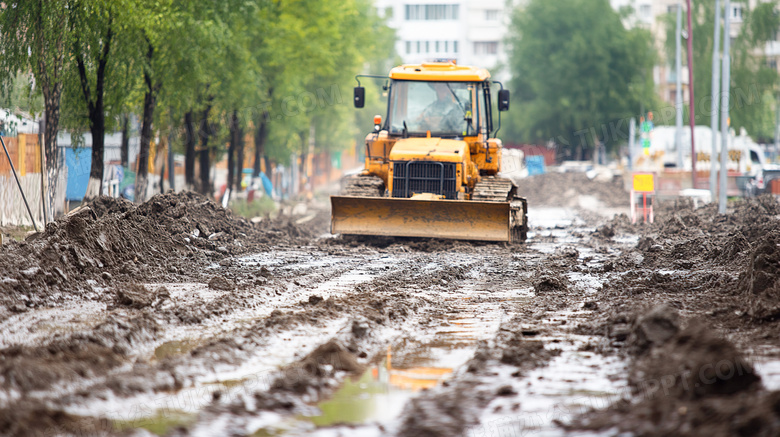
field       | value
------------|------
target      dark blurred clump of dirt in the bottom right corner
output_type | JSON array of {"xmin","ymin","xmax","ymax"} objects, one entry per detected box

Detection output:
[{"xmin": 570, "ymin": 306, "xmax": 780, "ymax": 437}]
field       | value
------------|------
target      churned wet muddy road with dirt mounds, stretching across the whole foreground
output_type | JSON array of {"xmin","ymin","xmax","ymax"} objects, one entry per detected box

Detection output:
[{"xmin": 0, "ymin": 174, "xmax": 780, "ymax": 437}]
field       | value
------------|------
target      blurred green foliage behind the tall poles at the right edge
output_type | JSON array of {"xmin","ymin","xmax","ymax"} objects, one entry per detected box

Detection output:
[{"xmin": 665, "ymin": 0, "xmax": 780, "ymax": 141}]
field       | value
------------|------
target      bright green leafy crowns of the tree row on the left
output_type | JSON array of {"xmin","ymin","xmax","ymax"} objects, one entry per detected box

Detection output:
[{"xmin": 0, "ymin": 0, "xmax": 395, "ymax": 172}]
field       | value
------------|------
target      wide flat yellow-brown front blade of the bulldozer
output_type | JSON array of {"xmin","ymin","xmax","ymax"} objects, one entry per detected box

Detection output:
[{"xmin": 330, "ymin": 196, "xmax": 512, "ymax": 242}]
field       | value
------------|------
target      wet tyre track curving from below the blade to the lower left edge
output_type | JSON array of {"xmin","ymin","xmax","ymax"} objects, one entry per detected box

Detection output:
[{"xmin": 0, "ymin": 247, "xmax": 464, "ymax": 434}]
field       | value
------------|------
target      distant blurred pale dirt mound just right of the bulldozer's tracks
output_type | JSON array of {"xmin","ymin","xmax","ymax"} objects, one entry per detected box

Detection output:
[{"xmin": 517, "ymin": 173, "xmax": 629, "ymax": 207}]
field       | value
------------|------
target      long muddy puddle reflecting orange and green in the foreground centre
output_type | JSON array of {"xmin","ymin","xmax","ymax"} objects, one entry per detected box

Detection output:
[{"xmin": 253, "ymin": 290, "xmax": 506, "ymax": 436}]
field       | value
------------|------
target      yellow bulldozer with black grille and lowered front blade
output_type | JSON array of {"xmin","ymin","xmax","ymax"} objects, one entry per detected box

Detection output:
[{"xmin": 331, "ymin": 62, "xmax": 528, "ymax": 242}]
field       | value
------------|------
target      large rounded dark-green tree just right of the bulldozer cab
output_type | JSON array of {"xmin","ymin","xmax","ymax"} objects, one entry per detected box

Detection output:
[{"xmin": 502, "ymin": 0, "xmax": 655, "ymax": 154}]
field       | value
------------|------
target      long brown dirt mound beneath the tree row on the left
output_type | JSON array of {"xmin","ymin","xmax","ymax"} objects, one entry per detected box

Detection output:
[{"xmin": 0, "ymin": 192, "xmax": 312, "ymax": 319}]
